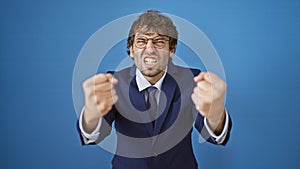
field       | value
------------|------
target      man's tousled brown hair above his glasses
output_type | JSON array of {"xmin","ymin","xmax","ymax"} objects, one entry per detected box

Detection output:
[{"xmin": 127, "ymin": 10, "xmax": 178, "ymax": 55}]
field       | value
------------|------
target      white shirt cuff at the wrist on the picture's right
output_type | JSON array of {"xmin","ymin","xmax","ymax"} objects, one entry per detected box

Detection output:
[{"xmin": 204, "ymin": 109, "xmax": 229, "ymax": 144}]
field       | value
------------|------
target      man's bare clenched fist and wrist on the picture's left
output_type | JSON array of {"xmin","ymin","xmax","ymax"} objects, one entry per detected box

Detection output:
[{"xmin": 82, "ymin": 74, "xmax": 118, "ymax": 127}]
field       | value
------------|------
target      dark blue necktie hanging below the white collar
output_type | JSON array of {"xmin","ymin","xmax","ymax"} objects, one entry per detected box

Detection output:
[{"xmin": 147, "ymin": 86, "xmax": 157, "ymax": 126}]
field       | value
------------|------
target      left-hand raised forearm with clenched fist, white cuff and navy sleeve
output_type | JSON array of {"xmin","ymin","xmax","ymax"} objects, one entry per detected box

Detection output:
[{"xmin": 78, "ymin": 74, "xmax": 118, "ymax": 144}]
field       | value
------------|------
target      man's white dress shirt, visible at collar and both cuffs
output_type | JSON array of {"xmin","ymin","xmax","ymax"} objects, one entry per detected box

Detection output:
[{"xmin": 79, "ymin": 69, "xmax": 229, "ymax": 144}]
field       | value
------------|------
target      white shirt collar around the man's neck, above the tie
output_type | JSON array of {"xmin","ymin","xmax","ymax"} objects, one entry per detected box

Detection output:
[{"xmin": 135, "ymin": 68, "xmax": 168, "ymax": 92}]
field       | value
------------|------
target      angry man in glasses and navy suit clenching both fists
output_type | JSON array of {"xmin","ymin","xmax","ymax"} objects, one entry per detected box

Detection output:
[{"xmin": 78, "ymin": 11, "xmax": 231, "ymax": 169}]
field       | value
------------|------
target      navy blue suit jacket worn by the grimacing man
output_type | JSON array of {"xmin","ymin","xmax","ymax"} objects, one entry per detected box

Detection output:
[{"xmin": 78, "ymin": 62, "xmax": 231, "ymax": 169}]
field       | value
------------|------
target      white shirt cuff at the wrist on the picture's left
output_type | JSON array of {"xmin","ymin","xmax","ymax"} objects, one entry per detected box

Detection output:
[{"xmin": 79, "ymin": 108, "xmax": 102, "ymax": 144}]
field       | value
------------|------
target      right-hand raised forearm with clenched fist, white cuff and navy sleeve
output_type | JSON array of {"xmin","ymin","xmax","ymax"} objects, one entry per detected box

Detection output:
[{"xmin": 192, "ymin": 72, "xmax": 231, "ymax": 144}]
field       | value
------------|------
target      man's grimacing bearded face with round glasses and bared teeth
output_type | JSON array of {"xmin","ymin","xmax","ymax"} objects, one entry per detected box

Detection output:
[{"xmin": 130, "ymin": 33, "xmax": 174, "ymax": 84}]
